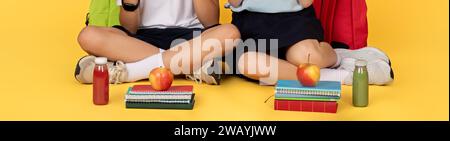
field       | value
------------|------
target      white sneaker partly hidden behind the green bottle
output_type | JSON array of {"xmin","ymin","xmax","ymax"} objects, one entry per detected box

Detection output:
[{"xmin": 338, "ymin": 58, "xmax": 394, "ymax": 85}]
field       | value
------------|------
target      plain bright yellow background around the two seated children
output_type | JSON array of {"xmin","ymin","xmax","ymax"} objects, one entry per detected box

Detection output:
[{"xmin": 0, "ymin": 0, "xmax": 449, "ymax": 121}]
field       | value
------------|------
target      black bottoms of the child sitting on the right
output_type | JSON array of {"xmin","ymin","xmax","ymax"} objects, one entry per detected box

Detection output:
[{"xmin": 232, "ymin": 6, "xmax": 324, "ymax": 59}]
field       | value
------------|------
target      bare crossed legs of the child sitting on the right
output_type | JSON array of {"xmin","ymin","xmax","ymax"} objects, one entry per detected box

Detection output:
[{"xmin": 238, "ymin": 40, "xmax": 336, "ymax": 84}]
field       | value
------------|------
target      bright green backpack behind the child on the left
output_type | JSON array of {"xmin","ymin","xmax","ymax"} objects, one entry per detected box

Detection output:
[{"xmin": 86, "ymin": 0, "xmax": 120, "ymax": 27}]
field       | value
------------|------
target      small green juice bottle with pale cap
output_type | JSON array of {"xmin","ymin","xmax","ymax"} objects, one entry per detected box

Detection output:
[{"xmin": 353, "ymin": 59, "xmax": 369, "ymax": 107}]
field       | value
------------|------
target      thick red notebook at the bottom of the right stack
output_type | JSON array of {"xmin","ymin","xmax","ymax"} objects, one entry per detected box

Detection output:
[{"xmin": 274, "ymin": 100, "xmax": 338, "ymax": 113}]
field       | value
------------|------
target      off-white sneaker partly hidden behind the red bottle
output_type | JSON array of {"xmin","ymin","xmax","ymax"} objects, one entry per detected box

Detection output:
[{"xmin": 75, "ymin": 55, "xmax": 128, "ymax": 84}]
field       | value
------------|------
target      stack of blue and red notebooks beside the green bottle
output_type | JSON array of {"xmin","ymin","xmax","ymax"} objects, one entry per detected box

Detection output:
[{"xmin": 274, "ymin": 80, "xmax": 341, "ymax": 113}]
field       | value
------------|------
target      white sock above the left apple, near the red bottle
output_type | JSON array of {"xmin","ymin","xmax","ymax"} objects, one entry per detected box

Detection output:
[{"xmin": 125, "ymin": 53, "xmax": 164, "ymax": 82}]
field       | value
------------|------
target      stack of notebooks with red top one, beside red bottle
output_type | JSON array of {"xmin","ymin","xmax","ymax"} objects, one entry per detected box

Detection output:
[{"xmin": 125, "ymin": 85, "xmax": 195, "ymax": 110}]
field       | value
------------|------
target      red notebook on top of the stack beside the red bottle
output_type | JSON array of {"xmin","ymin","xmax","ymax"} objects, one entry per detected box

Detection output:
[{"xmin": 130, "ymin": 85, "xmax": 193, "ymax": 94}]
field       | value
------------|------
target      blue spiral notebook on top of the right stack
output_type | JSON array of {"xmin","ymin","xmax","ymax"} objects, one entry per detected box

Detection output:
[{"xmin": 275, "ymin": 80, "xmax": 341, "ymax": 96}]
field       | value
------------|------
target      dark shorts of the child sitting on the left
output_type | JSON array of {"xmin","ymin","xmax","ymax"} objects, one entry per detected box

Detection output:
[{"xmin": 113, "ymin": 25, "xmax": 218, "ymax": 50}]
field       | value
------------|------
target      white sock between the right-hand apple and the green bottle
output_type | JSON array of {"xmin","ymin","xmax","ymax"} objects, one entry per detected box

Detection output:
[{"xmin": 320, "ymin": 69, "xmax": 351, "ymax": 83}]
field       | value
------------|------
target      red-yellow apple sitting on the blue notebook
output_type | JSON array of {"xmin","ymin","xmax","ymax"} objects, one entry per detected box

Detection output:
[{"xmin": 297, "ymin": 63, "xmax": 320, "ymax": 87}]
